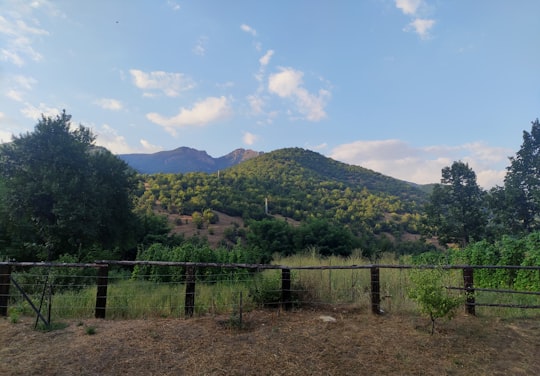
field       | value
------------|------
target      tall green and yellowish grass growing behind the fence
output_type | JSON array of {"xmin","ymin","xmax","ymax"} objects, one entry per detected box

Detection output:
[{"xmin": 12, "ymin": 250, "xmax": 540, "ymax": 319}]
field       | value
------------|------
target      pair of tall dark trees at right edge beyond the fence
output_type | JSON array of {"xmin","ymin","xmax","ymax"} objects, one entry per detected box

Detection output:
[{"xmin": 423, "ymin": 119, "xmax": 540, "ymax": 247}]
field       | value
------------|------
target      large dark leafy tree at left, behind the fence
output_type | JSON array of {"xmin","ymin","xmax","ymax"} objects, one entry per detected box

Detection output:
[{"xmin": 0, "ymin": 112, "xmax": 135, "ymax": 260}]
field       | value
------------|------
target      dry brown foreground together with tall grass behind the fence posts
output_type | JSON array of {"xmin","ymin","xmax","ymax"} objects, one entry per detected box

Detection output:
[{"xmin": 4, "ymin": 254, "xmax": 540, "ymax": 375}]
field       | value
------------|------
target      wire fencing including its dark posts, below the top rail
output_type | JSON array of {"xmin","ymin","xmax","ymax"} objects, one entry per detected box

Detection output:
[{"xmin": 0, "ymin": 261, "xmax": 540, "ymax": 319}]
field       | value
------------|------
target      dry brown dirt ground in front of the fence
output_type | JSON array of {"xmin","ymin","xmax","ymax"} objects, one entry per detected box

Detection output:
[{"xmin": 0, "ymin": 310, "xmax": 540, "ymax": 376}]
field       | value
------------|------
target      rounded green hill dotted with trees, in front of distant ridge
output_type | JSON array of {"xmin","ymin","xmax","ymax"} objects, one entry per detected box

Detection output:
[{"xmin": 138, "ymin": 148, "xmax": 428, "ymax": 253}]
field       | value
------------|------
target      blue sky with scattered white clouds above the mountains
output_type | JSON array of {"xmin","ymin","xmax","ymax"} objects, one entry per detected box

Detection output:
[{"xmin": 0, "ymin": 0, "xmax": 540, "ymax": 189}]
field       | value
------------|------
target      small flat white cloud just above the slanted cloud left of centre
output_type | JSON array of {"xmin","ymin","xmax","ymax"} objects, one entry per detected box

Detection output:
[{"xmin": 129, "ymin": 69, "xmax": 195, "ymax": 97}]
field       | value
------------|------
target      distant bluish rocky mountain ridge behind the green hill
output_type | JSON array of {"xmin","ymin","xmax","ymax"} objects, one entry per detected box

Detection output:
[{"xmin": 118, "ymin": 147, "xmax": 262, "ymax": 174}]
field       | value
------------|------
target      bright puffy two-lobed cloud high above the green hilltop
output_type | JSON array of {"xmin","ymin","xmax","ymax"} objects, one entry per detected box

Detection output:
[{"xmin": 268, "ymin": 68, "xmax": 331, "ymax": 121}]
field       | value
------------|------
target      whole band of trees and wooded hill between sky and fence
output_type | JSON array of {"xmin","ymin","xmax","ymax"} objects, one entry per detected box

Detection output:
[{"xmin": 0, "ymin": 112, "xmax": 540, "ymax": 268}]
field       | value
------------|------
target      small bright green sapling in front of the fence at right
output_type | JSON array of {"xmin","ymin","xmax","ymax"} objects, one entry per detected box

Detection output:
[{"xmin": 409, "ymin": 268, "xmax": 464, "ymax": 334}]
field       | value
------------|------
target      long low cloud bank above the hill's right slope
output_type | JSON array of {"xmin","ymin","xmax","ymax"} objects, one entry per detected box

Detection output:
[{"xmin": 330, "ymin": 140, "xmax": 511, "ymax": 188}]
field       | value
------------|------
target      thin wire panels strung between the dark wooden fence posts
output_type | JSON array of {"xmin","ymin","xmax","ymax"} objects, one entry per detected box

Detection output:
[{"xmin": 1, "ymin": 265, "xmax": 540, "ymax": 319}]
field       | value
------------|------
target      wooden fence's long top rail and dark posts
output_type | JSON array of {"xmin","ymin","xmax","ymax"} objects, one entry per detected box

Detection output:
[{"xmin": 0, "ymin": 260, "xmax": 540, "ymax": 318}]
